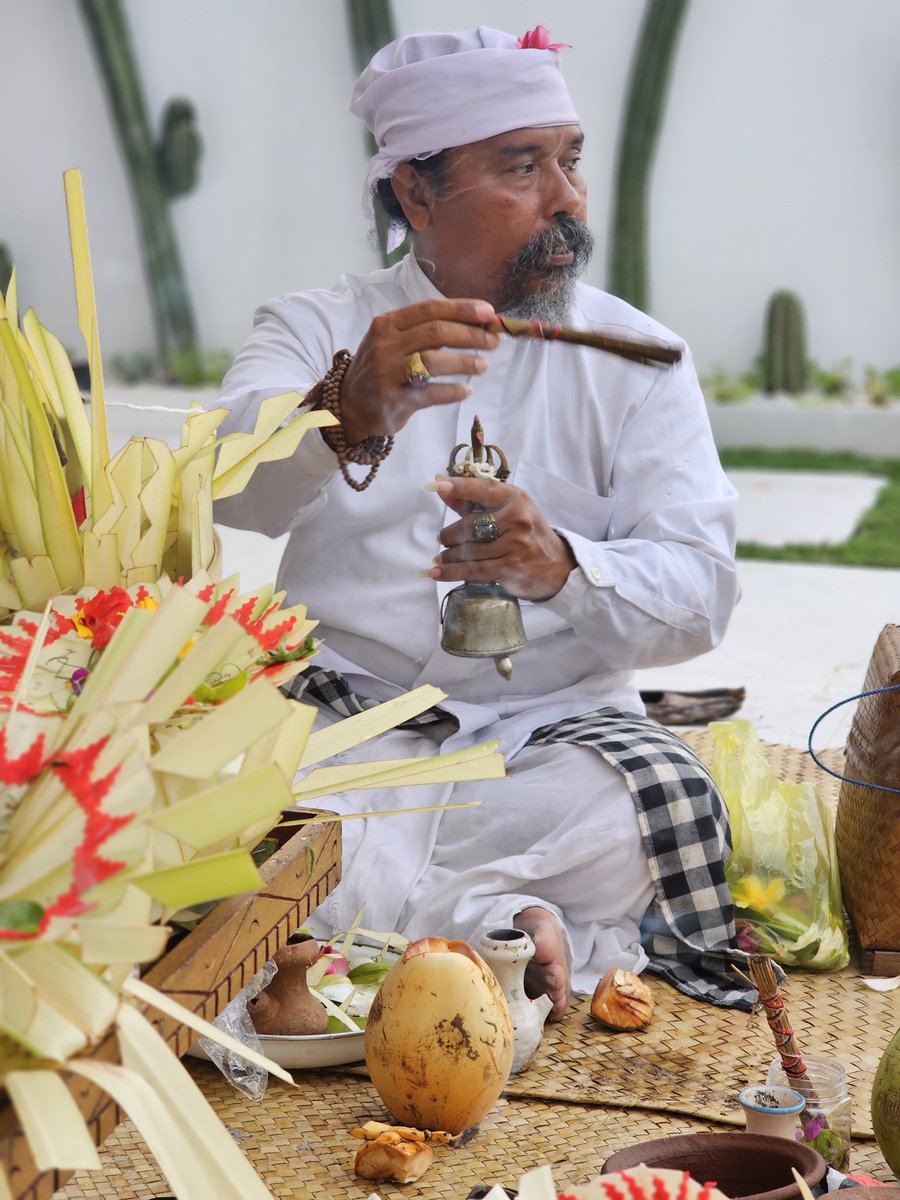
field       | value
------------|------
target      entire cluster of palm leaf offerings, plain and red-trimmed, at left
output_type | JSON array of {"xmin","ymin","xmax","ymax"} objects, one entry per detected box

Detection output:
[{"xmin": 0, "ymin": 172, "xmax": 504, "ymax": 1200}]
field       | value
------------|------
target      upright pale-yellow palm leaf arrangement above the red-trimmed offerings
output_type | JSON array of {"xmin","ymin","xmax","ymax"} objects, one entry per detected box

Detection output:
[{"xmin": 0, "ymin": 170, "xmax": 335, "ymax": 618}]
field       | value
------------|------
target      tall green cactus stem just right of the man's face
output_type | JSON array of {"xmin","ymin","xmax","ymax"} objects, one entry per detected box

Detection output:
[{"xmin": 608, "ymin": 0, "xmax": 688, "ymax": 308}]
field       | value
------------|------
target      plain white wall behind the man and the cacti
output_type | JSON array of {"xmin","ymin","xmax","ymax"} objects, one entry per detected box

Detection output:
[{"xmin": 0, "ymin": 0, "xmax": 900, "ymax": 370}]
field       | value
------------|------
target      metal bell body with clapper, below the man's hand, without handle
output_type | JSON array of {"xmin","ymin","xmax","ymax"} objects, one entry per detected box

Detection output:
[{"xmin": 440, "ymin": 583, "xmax": 526, "ymax": 679}]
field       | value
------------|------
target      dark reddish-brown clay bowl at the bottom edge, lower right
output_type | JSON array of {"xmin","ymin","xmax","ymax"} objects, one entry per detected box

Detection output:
[{"xmin": 601, "ymin": 1133, "xmax": 827, "ymax": 1200}]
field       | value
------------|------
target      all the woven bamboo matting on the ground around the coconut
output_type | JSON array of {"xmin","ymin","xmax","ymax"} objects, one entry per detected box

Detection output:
[{"xmin": 58, "ymin": 732, "xmax": 899, "ymax": 1200}]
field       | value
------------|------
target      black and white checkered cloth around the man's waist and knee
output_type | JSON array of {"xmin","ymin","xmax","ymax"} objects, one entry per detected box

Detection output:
[{"xmin": 282, "ymin": 667, "xmax": 756, "ymax": 1010}]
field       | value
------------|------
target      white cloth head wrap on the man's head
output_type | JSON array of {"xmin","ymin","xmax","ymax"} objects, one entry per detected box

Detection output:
[{"xmin": 350, "ymin": 25, "xmax": 578, "ymax": 238}]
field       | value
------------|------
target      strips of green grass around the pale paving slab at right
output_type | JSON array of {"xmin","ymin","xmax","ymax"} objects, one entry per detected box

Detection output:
[{"xmin": 720, "ymin": 448, "xmax": 900, "ymax": 568}]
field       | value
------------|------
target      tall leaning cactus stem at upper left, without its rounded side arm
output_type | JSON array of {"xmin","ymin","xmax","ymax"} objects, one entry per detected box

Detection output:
[{"xmin": 80, "ymin": 0, "xmax": 199, "ymax": 379}]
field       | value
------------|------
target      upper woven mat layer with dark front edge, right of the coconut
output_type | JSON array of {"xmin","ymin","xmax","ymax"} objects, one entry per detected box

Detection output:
[{"xmin": 336, "ymin": 732, "xmax": 883, "ymax": 1138}]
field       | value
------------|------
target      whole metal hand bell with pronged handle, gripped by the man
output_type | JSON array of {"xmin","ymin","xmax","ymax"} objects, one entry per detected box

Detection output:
[{"xmin": 440, "ymin": 416, "xmax": 526, "ymax": 679}]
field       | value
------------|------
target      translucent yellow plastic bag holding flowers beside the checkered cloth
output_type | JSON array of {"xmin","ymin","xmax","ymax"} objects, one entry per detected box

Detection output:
[{"xmin": 709, "ymin": 721, "xmax": 850, "ymax": 971}]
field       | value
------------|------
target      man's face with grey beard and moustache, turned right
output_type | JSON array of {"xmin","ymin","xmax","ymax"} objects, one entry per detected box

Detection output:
[{"xmin": 415, "ymin": 125, "xmax": 590, "ymax": 320}]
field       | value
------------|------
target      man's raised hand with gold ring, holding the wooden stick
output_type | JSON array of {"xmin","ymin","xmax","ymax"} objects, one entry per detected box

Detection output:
[{"xmin": 341, "ymin": 300, "xmax": 499, "ymax": 445}]
